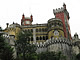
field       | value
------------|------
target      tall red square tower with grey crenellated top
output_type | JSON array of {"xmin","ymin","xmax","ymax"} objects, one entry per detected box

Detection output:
[{"xmin": 53, "ymin": 4, "xmax": 71, "ymax": 39}]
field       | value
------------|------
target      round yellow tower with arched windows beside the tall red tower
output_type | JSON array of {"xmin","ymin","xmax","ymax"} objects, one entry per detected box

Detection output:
[{"xmin": 48, "ymin": 18, "xmax": 64, "ymax": 39}]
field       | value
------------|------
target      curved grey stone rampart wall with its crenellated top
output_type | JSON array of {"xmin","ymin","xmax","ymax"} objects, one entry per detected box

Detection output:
[{"xmin": 35, "ymin": 37, "xmax": 72, "ymax": 55}]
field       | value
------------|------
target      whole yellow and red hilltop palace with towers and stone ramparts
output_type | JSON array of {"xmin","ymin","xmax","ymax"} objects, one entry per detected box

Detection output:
[{"xmin": 4, "ymin": 4, "xmax": 80, "ymax": 60}]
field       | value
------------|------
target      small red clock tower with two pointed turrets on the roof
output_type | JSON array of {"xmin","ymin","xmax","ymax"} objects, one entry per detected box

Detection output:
[{"xmin": 21, "ymin": 14, "xmax": 33, "ymax": 26}]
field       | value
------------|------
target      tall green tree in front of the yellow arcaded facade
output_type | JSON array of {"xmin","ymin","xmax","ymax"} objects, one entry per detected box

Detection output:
[{"xmin": 15, "ymin": 31, "xmax": 36, "ymax": 60}]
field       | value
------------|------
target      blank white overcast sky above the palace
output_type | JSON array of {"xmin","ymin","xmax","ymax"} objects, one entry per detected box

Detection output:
[{"xmin": 0, "ymin": 0, "xmax": 80, "ymax": 37}]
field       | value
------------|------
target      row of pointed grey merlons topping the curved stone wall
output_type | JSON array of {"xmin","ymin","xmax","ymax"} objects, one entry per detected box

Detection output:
[{"xmin": 32, "ymin": 37, "xmax": 72, "ymax": 48}]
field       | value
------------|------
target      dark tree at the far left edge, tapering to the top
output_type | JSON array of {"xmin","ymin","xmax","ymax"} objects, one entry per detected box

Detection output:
[{"xmin": 0, "ymin": 29, "xmax": 14, "ymax": 60}]
